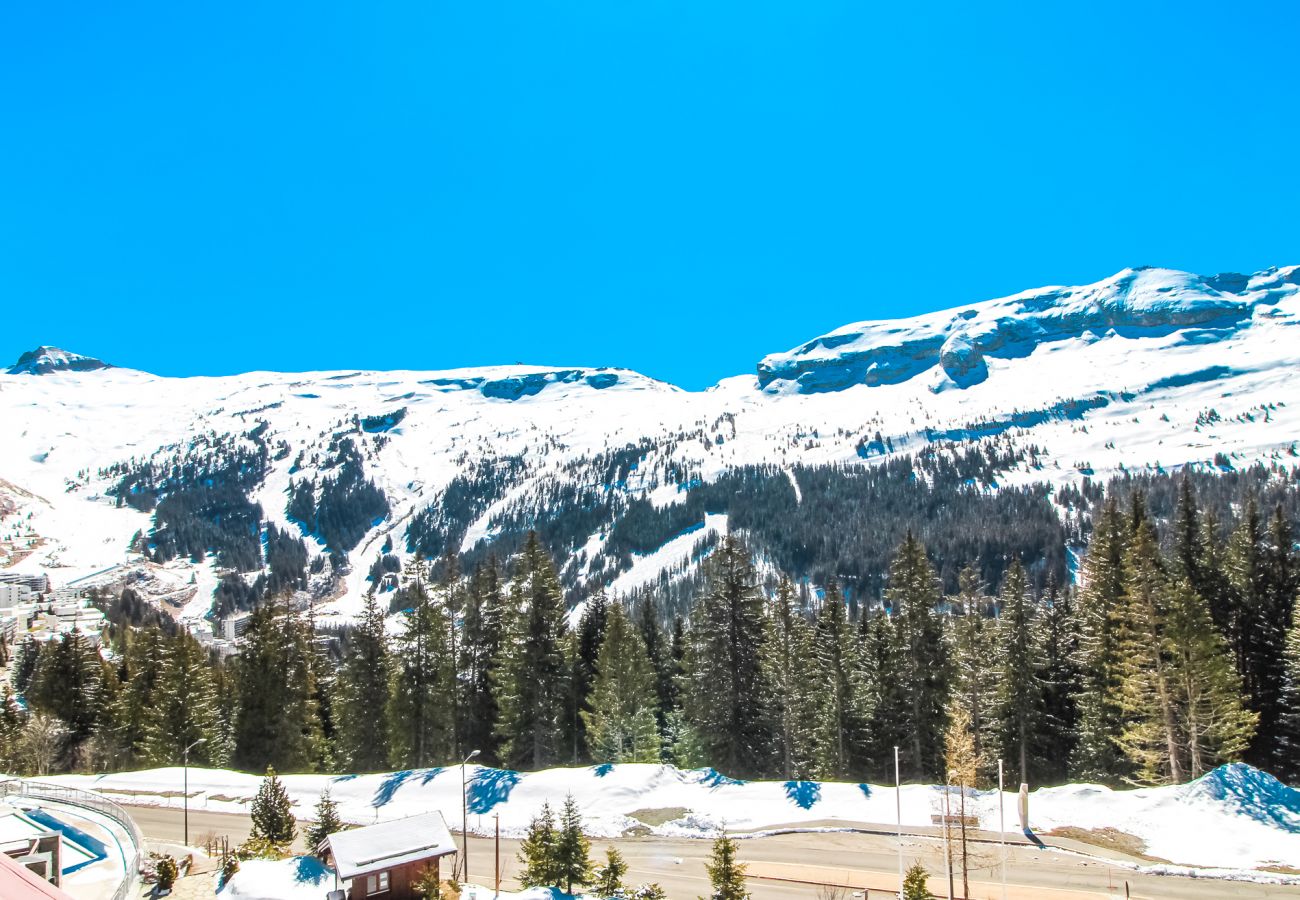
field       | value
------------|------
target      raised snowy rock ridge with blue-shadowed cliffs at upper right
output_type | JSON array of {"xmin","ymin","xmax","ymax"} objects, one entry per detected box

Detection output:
[{"xmin": 758, "ymin": 267, "xmax": 1300, "ymax": 394}]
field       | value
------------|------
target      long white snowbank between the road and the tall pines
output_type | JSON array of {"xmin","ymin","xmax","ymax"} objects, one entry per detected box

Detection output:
[{"xmin": 49, "ymin": 765, "xmax": 1300, "ymax": 870}]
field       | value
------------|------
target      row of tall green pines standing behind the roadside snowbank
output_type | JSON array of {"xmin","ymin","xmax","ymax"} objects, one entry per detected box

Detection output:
[{"xmin": 5, "ymin": 479, "xmax": 1300, "ymax": 784}]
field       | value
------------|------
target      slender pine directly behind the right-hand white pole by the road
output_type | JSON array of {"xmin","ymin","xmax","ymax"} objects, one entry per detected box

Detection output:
[{"xmin": 995, "ymin": 559, "xmax": 1044, "ymax": 783}]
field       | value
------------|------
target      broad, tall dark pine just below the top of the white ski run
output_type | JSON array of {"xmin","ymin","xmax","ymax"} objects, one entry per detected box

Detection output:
[{"xmin": 684, "ymin": 535, "xmax": 771, "ymax": 775}]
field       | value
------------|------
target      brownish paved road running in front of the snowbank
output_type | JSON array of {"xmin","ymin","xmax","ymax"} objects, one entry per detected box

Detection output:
[{"xmin": 130, "ymin": 806, "xmax": 1297, "ymax": 900}]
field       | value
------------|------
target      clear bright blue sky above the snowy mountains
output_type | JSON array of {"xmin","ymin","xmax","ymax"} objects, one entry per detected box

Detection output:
[{"xmin": 0, "ymin": 0, "xmax": 1300, "ymax": 388}]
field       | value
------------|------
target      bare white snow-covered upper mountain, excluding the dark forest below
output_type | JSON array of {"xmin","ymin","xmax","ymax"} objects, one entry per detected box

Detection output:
[{"xmin": 0, "ymin": 267, "xmax": 1300, "ymax": 629}]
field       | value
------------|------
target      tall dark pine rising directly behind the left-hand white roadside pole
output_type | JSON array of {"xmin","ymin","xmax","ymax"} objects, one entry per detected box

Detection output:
[{"xmin": 885, "ymin": 531, "xmax": 949, "ymax": 779}]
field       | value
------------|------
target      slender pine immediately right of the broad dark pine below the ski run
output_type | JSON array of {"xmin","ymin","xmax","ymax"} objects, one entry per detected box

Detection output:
[{"xmin": 763, "ymin": 579, "xmax": 819, "ymax": 780}]
